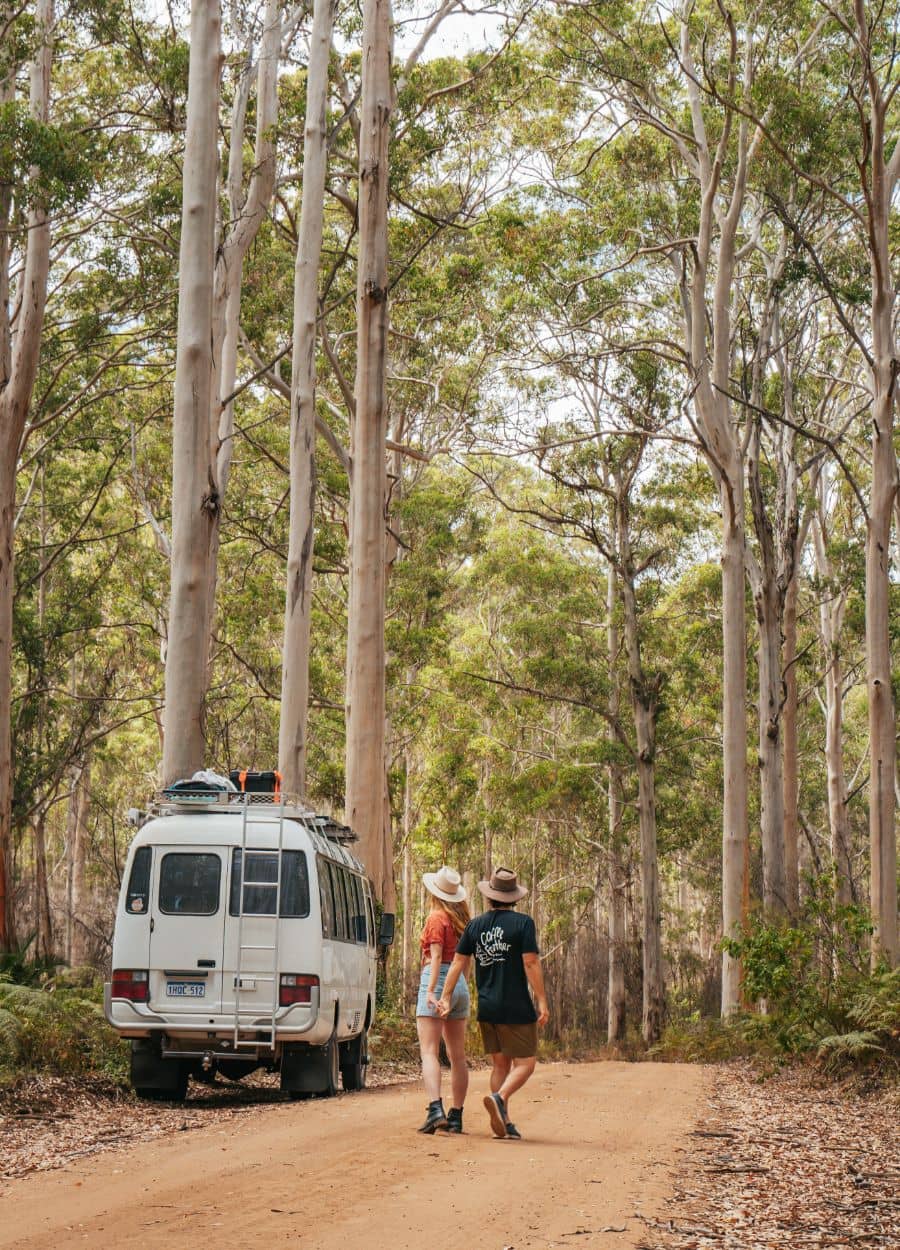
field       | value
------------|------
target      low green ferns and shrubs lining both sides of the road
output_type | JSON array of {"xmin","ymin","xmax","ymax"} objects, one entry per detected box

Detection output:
[{"xmin": 0, "ymin": 950, "xmax": 900, "ymax": 1090}]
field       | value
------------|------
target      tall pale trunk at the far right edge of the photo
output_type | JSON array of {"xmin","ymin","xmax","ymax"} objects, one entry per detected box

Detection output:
[{"xmin": 854, "ymin": 0, "xmax": 900, "ymax": 968}]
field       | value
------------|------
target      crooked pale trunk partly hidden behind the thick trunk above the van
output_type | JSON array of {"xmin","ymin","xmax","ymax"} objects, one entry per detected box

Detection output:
[{"xmin": 208, "ymin": 0, "xmax": 281, "ymax": 670}]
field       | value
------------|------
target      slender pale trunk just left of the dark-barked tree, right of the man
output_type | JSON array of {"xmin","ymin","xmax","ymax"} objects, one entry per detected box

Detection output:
[{"xmin": 606, "ymin": 563, "xmax": 626, "ymax": 1045}]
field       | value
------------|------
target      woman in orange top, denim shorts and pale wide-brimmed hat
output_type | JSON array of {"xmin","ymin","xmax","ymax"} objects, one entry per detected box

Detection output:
[{"xmin": 416, "ymin": 865, "xmax": 471, "ymax": 1133}]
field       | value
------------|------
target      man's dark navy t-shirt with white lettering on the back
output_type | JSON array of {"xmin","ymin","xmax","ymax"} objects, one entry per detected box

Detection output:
[{"xmin": 456, "ymin": 908, "xmax": 538, "ymax": 1024}]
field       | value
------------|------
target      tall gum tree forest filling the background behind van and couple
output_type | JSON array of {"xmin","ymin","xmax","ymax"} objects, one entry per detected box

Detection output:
[{"xmin": 0, "ymin": 0, "xmax": 900, "ymax": 1095}]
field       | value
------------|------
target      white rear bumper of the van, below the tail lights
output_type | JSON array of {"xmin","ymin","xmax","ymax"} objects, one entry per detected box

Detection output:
[{"xmin": 104, "ymin": 981, "xmax": 320, "ymax": 1045}]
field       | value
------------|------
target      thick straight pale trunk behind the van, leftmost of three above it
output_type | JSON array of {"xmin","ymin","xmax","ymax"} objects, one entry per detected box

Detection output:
[{"xmin": 163, "ymin": 0, "xmax": 223, "ymax": 785}]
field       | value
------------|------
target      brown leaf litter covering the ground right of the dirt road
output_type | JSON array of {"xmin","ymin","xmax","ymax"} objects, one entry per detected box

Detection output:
[{"xmin": 640, "ymin": 1065, "xmax": 900, "ymax": 1250}]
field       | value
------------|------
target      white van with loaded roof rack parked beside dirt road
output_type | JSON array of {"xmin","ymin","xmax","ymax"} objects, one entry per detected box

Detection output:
[{"xmin": 105, "ymin": 791, "xmax": 394, "ymax": 1099}]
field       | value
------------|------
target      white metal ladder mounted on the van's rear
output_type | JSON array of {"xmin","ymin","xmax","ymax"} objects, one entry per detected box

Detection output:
[{"xmin": 233, "ymin": 793, "xmax": 285, "ymax": 1050}]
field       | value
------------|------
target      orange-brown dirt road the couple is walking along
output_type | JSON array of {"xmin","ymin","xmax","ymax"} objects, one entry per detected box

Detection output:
[{"xmin": 0, "ymin": 1063, "xmax": 710, "ymax": 1250}]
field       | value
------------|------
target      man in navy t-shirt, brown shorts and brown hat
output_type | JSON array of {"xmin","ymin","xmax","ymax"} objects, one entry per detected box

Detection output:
[{"xmin": 438, "ymin": 868, "xmax": 550, "ymax": 1140}]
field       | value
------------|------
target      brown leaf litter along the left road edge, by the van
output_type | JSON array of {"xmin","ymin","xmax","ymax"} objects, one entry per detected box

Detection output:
[{"xmin": 0, "ymin": 1064, "xmax": 418, "ymax": 1193}]
